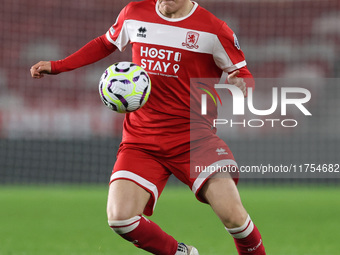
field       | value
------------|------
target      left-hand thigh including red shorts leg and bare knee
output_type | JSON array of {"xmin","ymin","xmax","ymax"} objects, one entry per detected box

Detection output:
[{"xmin": 108, "ymin": 146, "xmax": 171, "ymax": 220}]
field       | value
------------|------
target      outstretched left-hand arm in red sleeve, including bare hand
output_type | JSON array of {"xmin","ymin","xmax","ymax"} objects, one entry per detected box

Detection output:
[{"xmin": 30, "ymin": 35, "xmax": 117, "ymax": 79}]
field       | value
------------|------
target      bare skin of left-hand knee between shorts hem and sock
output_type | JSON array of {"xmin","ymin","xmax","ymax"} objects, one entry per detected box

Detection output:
[{"xmin": 107, "ymin": 179, "xmax": 151, "ymax": 221}]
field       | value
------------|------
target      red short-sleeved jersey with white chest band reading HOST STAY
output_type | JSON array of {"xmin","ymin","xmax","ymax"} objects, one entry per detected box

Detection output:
[{"xmin": 106, "ymin": 0, "xmax": 246, "ymax": 156}]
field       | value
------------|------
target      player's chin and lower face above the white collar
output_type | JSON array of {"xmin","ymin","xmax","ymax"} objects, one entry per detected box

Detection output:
[{"xmin": 158, "ymin": 0, "xmax": 193, "ymax": 18}]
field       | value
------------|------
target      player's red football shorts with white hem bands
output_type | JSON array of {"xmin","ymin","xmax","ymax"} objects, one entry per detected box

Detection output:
[{"xmin": 110, "ymin": 135, "xmax": 238, "ymax": 216}]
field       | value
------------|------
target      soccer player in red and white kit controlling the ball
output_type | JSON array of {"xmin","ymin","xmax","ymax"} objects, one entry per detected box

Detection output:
[{"xmin": 31, "ymin": 0, "xmax": 265, "ymax": 255}]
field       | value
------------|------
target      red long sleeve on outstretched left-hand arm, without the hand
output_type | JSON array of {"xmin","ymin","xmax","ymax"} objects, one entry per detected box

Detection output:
[{"xmin": 51, "ymin": 35, "xmax": 116, "ymax": 74}]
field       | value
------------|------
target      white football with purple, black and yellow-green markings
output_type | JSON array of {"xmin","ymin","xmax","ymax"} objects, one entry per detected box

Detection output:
[{"xmin": 99, "ymin": 62, "xmax": 151, "ymax": 113}]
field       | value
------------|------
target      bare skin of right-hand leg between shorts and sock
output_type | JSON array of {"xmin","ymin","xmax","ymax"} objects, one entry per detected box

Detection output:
[{"xmin": 199, "ymin": 173, "xmax": 248, "ymax": 228}]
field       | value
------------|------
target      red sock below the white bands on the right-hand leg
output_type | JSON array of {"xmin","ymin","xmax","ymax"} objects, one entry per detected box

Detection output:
[{"xmin": 234, "ymin": 225, "xmax": 266, "ymax": 255}]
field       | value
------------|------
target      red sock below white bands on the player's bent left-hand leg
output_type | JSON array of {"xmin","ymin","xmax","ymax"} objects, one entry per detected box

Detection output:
[{"xmin": 121, "ymin": 217, "xmax": 178, "ymax": 255}]
